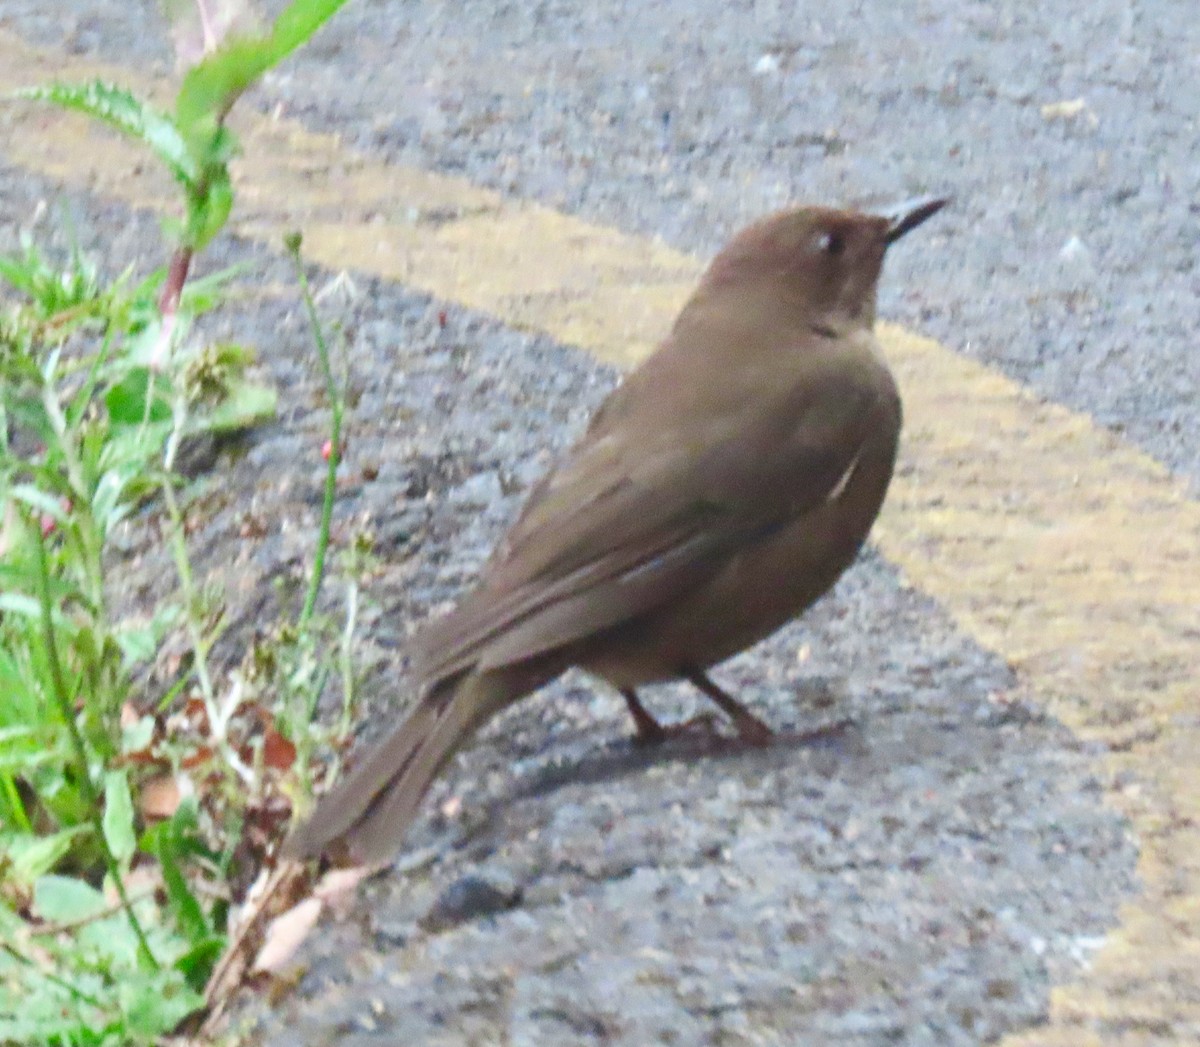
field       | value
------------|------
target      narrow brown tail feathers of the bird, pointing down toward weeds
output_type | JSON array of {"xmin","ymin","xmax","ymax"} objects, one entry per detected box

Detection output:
[{"xmin": 283, "ymin": 670, "xmax": 550, "ymax": 864}]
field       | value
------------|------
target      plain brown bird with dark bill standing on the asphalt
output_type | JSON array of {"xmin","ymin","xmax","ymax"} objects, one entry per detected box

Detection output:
[{"xmin": 284, "ymin": 198, "xmax": 946, "ymax": 863}]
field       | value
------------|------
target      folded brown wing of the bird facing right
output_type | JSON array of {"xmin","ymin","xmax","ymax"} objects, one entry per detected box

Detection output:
[{"xmin": 415, "ymin": 370, "xmax": 881, "ymax": 684}]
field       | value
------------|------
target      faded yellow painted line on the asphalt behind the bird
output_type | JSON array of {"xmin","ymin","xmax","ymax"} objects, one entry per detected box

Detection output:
[{"xmin": 0, "ymin": 34, "xmax": 1200, "ymax": 1047}]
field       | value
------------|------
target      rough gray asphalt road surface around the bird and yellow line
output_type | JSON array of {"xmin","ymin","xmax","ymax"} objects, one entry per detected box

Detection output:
[{"xmin": 0, "ymin": 0, "xmax": 1185, "ymax": 1045}]
